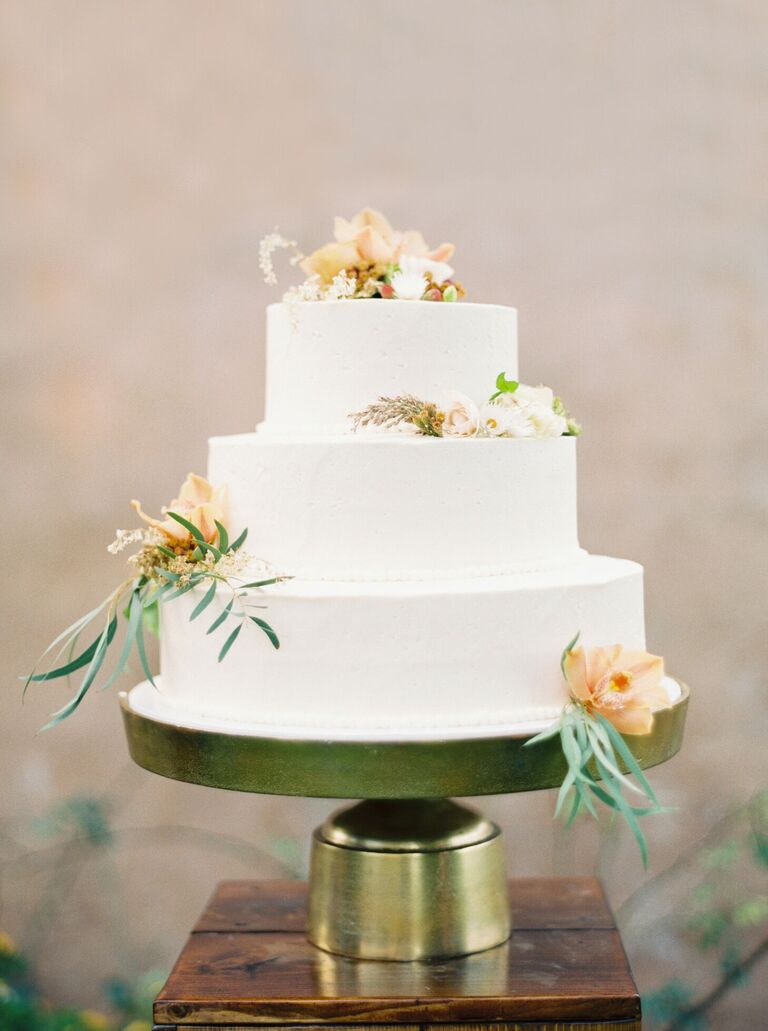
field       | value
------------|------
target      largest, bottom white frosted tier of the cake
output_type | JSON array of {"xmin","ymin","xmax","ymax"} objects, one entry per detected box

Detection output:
[{"xmin": 158, "ymin": 556, "xmax": 645, "ymax": 737}]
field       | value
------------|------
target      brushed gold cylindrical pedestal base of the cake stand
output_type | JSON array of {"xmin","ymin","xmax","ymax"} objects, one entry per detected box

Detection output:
[{"xmin": 308, "ymin": 798, "xmax": 510, "ymax": 961}]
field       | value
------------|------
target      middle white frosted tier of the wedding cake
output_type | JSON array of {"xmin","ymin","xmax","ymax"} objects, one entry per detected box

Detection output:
[{"xmin": 208, "ymin": 433, "xmax": 583, "ymax": 581}]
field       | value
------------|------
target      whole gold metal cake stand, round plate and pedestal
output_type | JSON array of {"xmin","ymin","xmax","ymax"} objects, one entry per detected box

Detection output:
[{"xmin": 121, "ymin": 681, "xmax": 690, "ymax": 961}]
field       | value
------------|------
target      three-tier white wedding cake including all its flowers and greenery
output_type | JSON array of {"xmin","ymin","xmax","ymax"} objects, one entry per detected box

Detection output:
[{"xmin": 27, "ymin": 209, "xmax": 687, "ymax": 870}]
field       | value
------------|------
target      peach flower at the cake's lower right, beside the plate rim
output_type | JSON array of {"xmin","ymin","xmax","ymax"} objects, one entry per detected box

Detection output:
[{"xmin": 563, "ymin": 644, "xmax": 669, "ymax": 734}]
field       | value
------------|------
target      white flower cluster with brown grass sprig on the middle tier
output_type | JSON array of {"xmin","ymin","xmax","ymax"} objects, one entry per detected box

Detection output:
[{"xmin": 349, "ymin": 372, "xmax": 581, "ymax": 437}]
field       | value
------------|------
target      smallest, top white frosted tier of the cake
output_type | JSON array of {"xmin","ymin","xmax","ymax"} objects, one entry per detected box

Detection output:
[{"xmin": 261, "ymin": 300, "xmax": 517, "ymax": 435}]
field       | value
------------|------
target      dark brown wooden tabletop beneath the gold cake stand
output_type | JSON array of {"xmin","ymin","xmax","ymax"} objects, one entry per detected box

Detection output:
[{"xmin": 155, "ymin": 877, "xmax": 640, "ymax": 1031}]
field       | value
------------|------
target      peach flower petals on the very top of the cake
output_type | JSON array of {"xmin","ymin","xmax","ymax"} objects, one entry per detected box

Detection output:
[{"xmin": 301, "ymin": 207, "xmax": 455, "ymax": 285}]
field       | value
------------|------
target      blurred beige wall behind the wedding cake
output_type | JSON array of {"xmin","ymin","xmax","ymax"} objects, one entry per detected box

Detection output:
[{"xmin": 0, "ymin": 0, "xmax": 768, "ymax": 1027}]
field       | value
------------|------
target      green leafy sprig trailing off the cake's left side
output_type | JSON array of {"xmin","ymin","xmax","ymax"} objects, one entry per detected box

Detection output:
[{"xmin": 24, "ymin": 511, "xmax": 289, "ymax": 730}]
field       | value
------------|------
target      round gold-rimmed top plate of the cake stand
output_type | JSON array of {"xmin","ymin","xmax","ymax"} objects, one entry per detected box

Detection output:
[{"xmin": 121, "ymin": 680, "xmax": 690, "ymax": 799}]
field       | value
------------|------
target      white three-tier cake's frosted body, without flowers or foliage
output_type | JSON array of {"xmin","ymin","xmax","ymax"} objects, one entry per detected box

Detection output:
[{"xmin": 158, "ymin": 294, "xmax": 645, "ymax": 739}]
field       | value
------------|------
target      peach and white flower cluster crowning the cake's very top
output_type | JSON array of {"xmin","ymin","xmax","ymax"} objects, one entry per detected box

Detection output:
[{"xmin": 259, "ymin": 207, "xmax": 464, "ymax": 301}]
